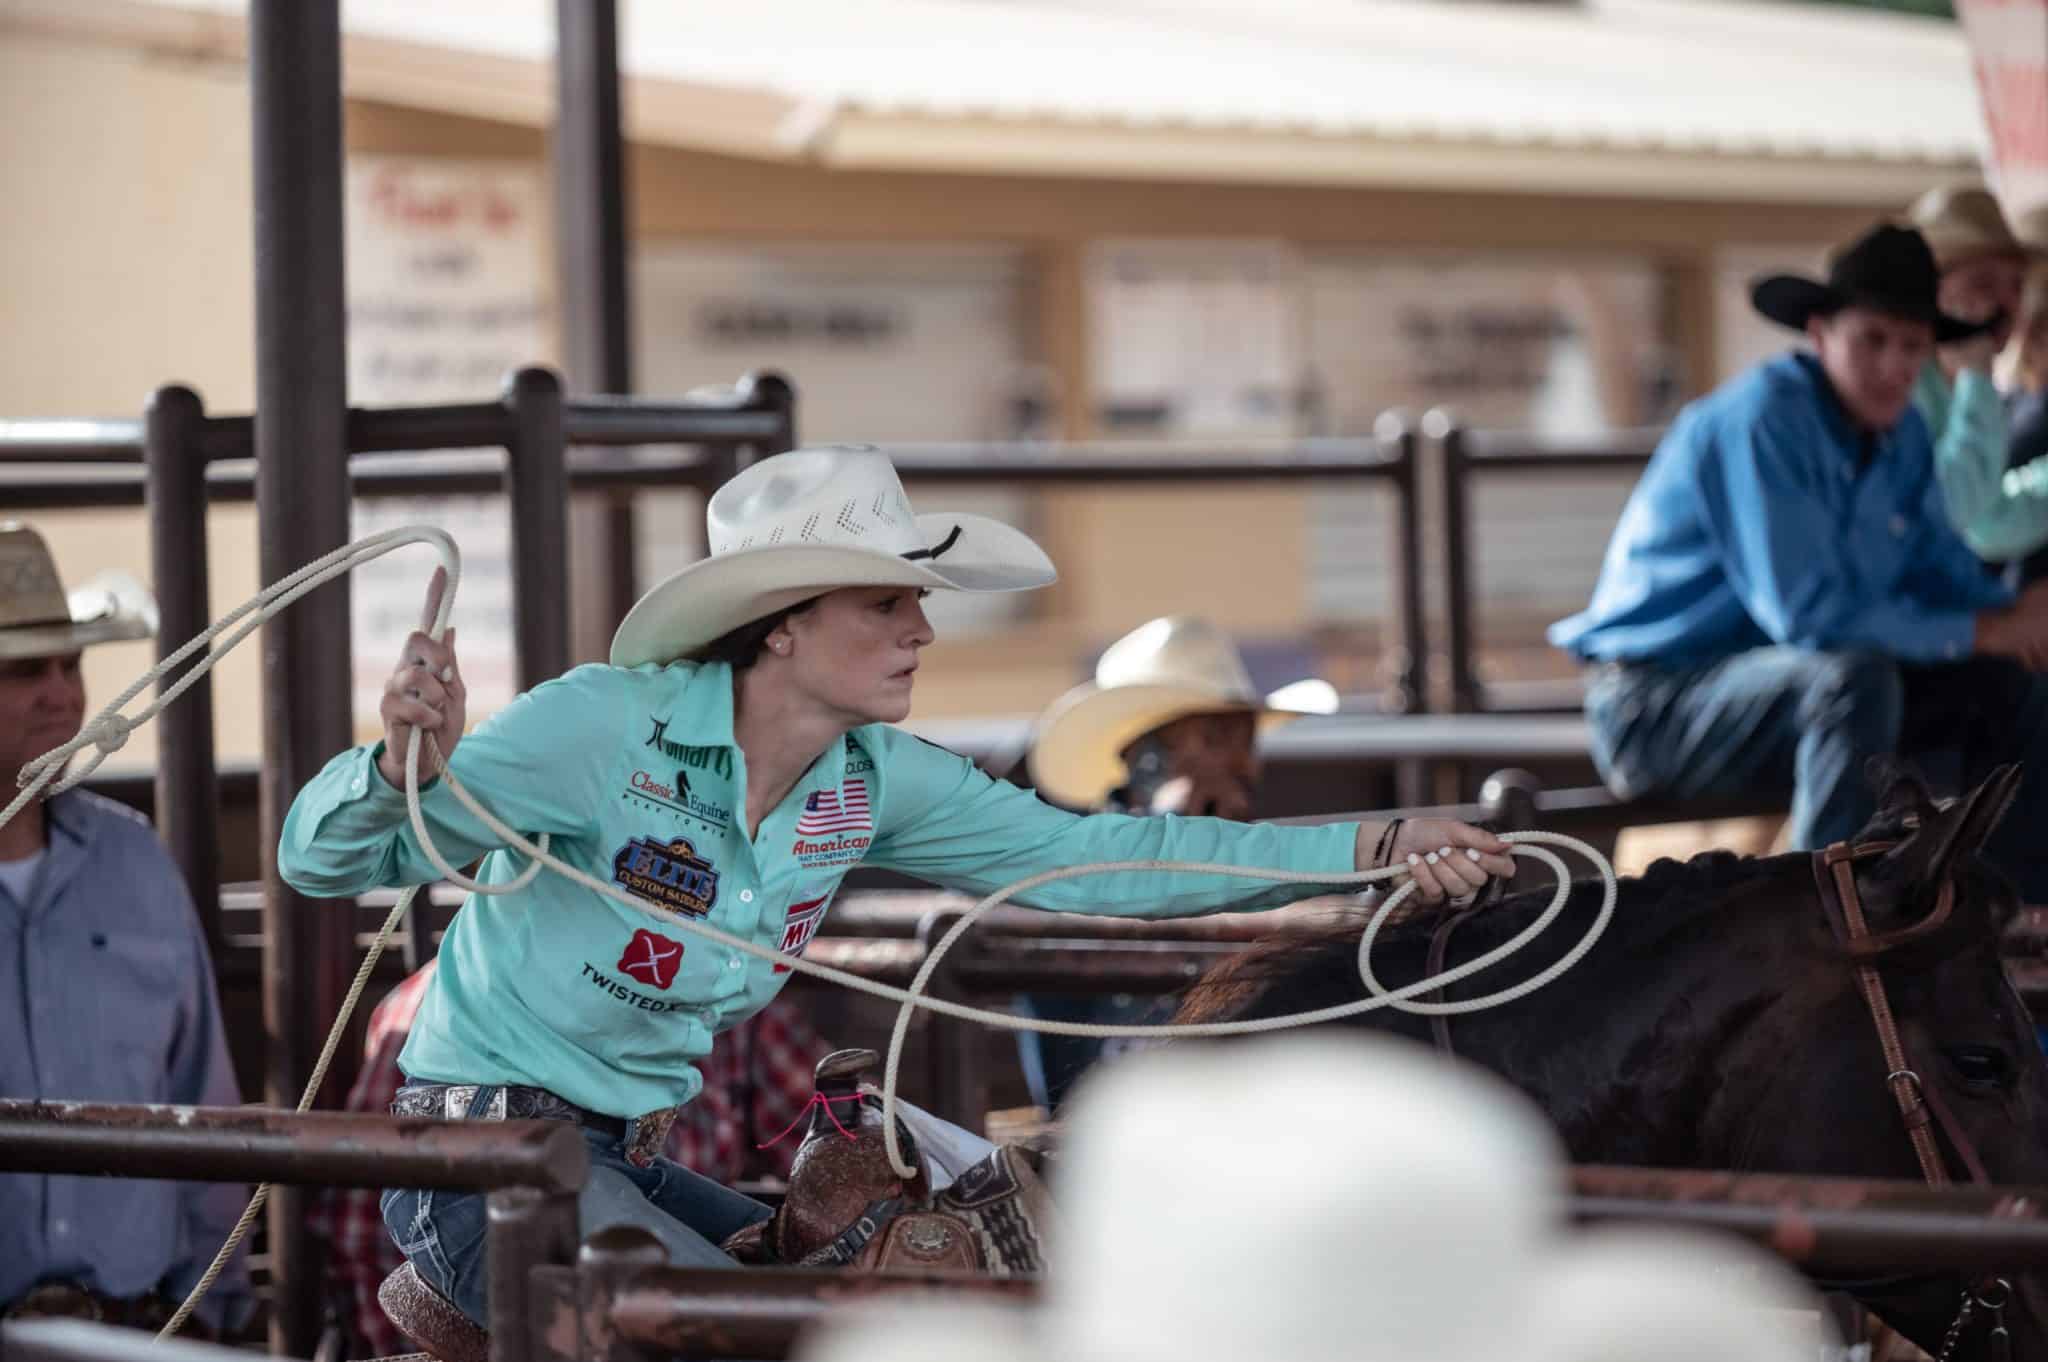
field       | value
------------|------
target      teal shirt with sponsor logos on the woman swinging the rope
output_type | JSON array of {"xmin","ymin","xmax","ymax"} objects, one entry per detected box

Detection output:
[{"xmin": 279, "ymin": 664, "xmax": 1358, "ymax": 1116}]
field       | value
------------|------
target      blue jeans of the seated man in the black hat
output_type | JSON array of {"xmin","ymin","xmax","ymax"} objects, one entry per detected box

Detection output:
[{"xmin": 1585, "ymin": 647, "xmax": 2048, "ymax": 903}]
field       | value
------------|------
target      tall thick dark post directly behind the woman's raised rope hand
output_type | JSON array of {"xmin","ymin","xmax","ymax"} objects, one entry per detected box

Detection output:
[{"xmin": 248, "ymin": 0, "xmax": 354, "ymax": 1335}]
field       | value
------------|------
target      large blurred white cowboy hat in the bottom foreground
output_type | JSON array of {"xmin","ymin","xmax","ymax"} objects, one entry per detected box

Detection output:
[{"xmin": 797, "ymin": 1032, "xmax": 1825, "ymax": 1362}]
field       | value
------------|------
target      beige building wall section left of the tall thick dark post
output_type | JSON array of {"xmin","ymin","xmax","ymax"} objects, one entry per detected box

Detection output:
[{"xmin": 0, "ymin": 33, "xmax": 262, "ymax": 766}]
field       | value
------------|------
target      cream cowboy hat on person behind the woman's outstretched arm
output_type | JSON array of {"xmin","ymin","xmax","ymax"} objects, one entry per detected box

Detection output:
[{"xmin": 1028, "ymin": 614, "xmax": 1337, "ymax": 809}]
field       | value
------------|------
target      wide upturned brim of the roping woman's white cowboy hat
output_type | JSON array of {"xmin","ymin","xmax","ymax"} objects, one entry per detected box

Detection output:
[{"xmin": 610, "ymin": 512, "xmax": 1059, "ymax": 668}]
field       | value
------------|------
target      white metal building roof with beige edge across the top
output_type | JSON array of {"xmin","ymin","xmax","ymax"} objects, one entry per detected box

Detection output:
[{"xmin": 0, "ymin": 0, "xmax": 1987, "ymax": 203}]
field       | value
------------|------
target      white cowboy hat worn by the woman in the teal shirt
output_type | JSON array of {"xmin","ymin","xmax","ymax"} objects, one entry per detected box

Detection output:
[{"xmin": 612, "ymin": 444, "xmax": 1059, "ymax": 668}]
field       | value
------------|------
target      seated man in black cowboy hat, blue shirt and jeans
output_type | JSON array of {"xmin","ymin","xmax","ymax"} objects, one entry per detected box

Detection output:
[{"xmin": 1550, "ymin": 225, "xmax": 2048, "ymax": 880}]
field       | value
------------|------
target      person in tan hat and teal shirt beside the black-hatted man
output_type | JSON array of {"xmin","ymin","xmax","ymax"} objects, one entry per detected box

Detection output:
[{"xmin": 1911, "ymin": 186, "xmax": 2048, "ymax": 563}]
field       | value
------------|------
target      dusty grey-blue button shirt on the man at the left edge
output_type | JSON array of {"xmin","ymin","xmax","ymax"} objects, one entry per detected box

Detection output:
[{"xmin": 0, "ymin": 791, "xmax": 248, "ymax": 1325}]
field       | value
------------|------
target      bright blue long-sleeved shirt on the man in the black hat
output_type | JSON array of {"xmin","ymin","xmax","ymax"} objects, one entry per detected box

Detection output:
[{"xmin": 1550, "ymin": 354, "xmax": 2011, "ymax": 666}]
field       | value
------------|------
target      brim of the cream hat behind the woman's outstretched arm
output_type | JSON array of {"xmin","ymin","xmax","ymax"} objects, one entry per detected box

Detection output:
[{"xmin": 1024, "ymin": 682, "xmax": 1329, "ymax": 809}]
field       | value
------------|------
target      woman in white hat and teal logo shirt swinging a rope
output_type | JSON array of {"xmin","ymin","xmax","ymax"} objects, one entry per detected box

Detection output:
[{"xmin": 279, "ymin": 446, "xmax": 1513, "ymax": 1321}]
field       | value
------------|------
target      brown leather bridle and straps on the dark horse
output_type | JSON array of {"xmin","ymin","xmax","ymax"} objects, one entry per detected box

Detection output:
[{"xmin": 1423, "ymin": 842, "xmax": 2011, "ymax": 1362}]
